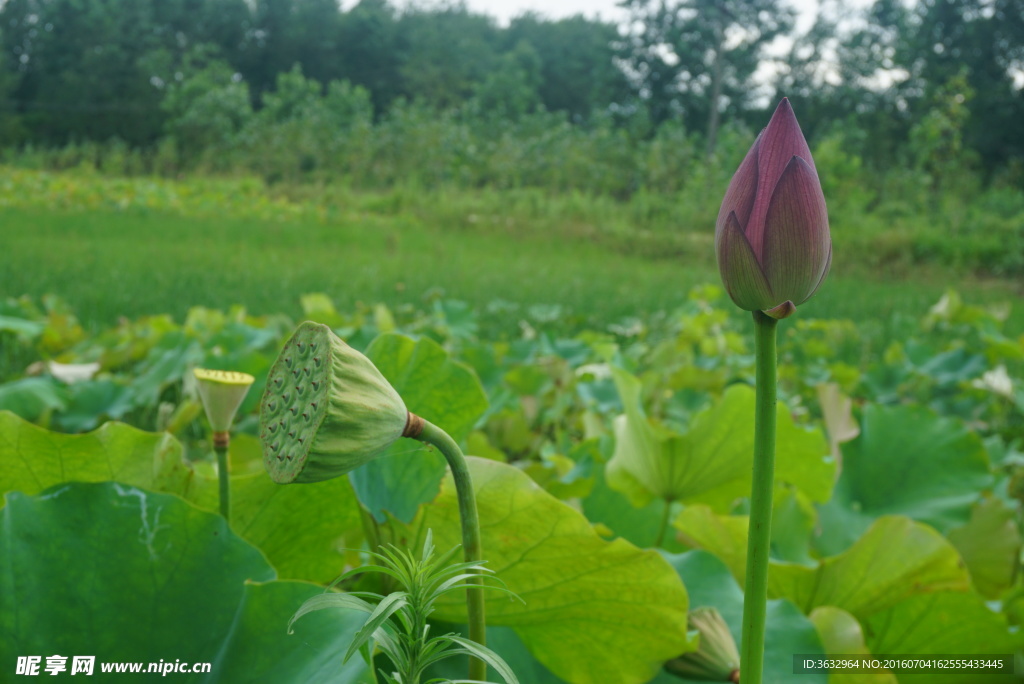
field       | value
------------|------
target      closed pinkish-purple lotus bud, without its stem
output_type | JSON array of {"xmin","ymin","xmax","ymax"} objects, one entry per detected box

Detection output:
[{"xmin": 715, "ymin": 98, "xmax": 831, "ymax": 318}]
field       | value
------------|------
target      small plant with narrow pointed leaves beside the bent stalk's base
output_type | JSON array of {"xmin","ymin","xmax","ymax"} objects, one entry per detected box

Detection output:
[{"xmin": 288, "ymin": 530, "xmax": 518, "ymax": 684}]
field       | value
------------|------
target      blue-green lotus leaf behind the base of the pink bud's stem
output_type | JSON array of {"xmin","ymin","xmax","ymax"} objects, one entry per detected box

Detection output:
[{"xmin": 658, "ymin": 551, "xmax": 828, "ymax": 684}]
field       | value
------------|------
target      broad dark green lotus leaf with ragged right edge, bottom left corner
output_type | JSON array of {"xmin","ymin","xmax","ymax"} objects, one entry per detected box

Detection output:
[{"xmin": 0, "ymin": 482, "xmax": 371, "ymax": 684}]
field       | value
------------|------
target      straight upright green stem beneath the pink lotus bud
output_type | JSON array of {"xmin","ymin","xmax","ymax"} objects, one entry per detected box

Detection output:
[{"xmin": 740, "ymin": 311, "xmax": 778, "ymax": 684}]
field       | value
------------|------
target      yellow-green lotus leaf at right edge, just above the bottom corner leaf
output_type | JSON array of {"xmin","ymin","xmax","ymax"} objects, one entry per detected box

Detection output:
[{"xmin": 946, "ymin": 497, "xmax": 1021, "ymax": 599}]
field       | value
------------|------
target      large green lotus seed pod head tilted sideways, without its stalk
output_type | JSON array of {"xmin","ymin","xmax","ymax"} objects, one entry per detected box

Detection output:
[{"xmin": 260, "ymin": 320, "xmax": 409, "ymax": 484}]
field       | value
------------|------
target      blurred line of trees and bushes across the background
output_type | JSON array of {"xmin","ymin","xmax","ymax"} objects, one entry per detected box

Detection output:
[{"xmin": 0, "ymin": 0, "xmax": 1024, "ymax": 195}]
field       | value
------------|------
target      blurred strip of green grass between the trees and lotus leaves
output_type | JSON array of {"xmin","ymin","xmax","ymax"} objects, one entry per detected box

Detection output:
[{"xmin": 0, "ymin": 172, "xmax": 1024, "ymax": 338}]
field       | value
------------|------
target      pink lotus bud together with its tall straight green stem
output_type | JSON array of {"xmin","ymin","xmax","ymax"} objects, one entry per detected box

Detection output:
[{"xmin": 715, "ymin": 99, "xmax": 831, "ymax": 684}]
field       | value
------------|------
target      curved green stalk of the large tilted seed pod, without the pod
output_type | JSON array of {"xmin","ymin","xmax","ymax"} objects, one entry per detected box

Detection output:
[{"xmin": 404, "ymin": 414, "xmax": 487, "ymax": 681}]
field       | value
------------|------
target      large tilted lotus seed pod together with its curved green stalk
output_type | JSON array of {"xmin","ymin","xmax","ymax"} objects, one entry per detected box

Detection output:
[{"xmin": 260, "ymin": 322, "xmax": 486, "ymax": 680}]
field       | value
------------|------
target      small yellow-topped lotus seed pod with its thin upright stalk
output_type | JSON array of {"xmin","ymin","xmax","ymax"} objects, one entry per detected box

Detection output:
[{"xmin": 193, "ymin": 369, "xmax": 256, "ymax": 521}]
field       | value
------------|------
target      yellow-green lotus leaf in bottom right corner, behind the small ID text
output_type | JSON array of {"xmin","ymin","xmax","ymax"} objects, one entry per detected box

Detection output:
[{"xmin": 862, "ymin": 592, "xmax": 1024, "ymax": 684}]
